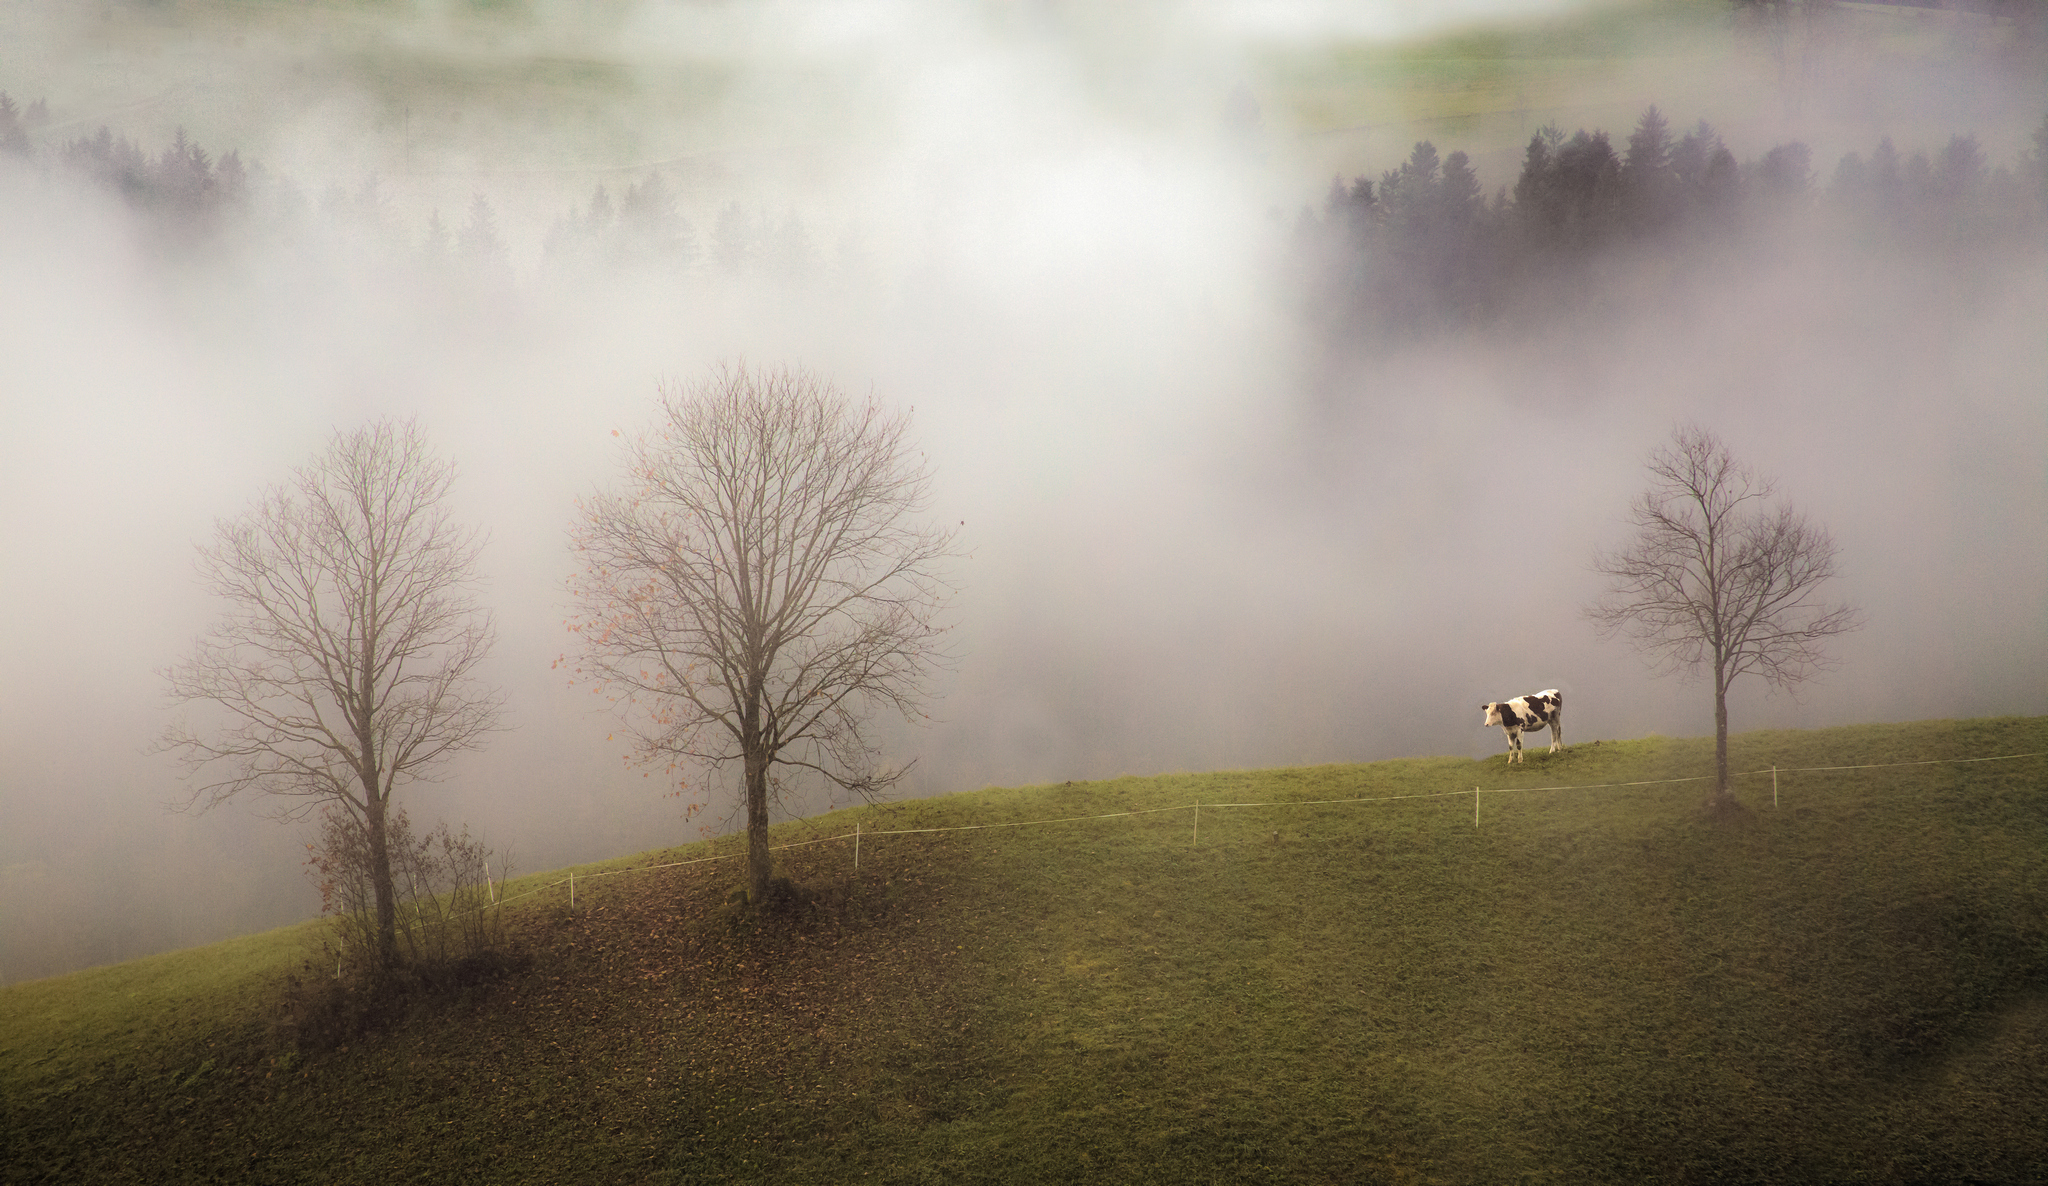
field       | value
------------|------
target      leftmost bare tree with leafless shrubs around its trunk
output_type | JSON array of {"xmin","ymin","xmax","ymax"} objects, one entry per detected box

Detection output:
[{"xmin": 158, "ymin": 422, "xmax": 502, "ymax": 967}]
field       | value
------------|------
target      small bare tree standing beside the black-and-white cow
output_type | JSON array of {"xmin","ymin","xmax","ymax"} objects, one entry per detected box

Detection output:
[{"xmin": 1585, "ymin": 424, "xmax": 1862, "ymax": 807}]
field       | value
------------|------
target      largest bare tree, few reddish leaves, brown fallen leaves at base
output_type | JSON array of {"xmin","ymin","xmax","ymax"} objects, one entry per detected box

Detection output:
[{"xmin": 571, "ymin": 365, "xmax": 952, "ymax": 903}]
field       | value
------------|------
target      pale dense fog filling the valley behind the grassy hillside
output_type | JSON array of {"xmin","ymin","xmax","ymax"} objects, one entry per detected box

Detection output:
[{"xmin": 0, "ymin": 0, "xmax": 2048, "ymax": 983}]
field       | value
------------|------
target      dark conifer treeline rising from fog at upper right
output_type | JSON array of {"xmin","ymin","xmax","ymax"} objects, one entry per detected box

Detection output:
[{"xmin": 1292, "ymin": 107, "xmax": 2048, "ymax": 340}]
